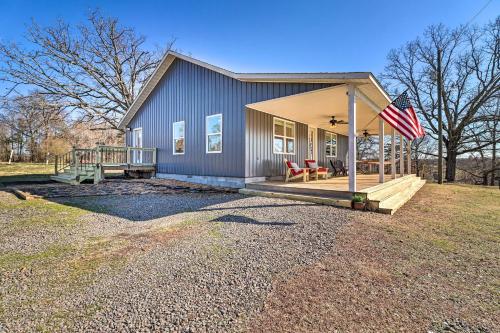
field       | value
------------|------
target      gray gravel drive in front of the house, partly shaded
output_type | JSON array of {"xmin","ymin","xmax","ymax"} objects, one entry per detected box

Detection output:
[{"xmin": 49, "ymin": 194, "xmax": 356, "ymax": 332}]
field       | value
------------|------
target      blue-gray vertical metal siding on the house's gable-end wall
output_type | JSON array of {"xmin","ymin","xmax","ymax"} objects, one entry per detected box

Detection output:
[{"xmin": 127, "ymin": 59, "xmax": 331, "ymax": 177}]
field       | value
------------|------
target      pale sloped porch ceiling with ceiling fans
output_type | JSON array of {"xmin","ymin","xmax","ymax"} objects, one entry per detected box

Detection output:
[{"xmin": 247, "ymin": 84, "xmax": 391, "ymax": 136}]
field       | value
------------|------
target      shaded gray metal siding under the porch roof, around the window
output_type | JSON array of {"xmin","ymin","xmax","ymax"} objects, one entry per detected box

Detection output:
[{"xmin": 245, "ymin": 109, "xmax": 307, "ymax": 177}]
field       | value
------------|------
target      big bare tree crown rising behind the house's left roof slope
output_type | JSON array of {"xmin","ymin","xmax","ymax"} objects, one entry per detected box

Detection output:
[{"xmin": 0, "ymin": 11, "xmax": 173, "ymax": 129}]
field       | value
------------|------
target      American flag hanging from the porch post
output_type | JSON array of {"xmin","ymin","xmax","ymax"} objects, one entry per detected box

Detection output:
[{"xmin": 379, "ymin": 91, "xmax": 425, "ymax": 140}]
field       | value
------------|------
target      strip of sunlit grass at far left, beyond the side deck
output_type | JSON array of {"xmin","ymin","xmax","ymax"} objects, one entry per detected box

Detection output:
[{"xmin": 0, "ymin": 162, "xmax": 54, "ymax": 183}]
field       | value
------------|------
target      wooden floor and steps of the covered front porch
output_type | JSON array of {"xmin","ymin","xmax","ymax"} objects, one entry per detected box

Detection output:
[{"xmin": 240, "ymin": 174, "xmax": 425, "ymax": 214}]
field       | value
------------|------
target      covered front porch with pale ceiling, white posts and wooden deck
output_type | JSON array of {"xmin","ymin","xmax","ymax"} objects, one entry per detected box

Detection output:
[{"xmin": 243, "ymin": 78, "xmax": 423, "ymax": 214}]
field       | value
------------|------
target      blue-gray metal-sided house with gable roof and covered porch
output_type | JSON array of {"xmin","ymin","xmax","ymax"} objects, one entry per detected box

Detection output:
[{"xmin": 119, "ymin": 51, "xmax": 426, "ymax": 213}]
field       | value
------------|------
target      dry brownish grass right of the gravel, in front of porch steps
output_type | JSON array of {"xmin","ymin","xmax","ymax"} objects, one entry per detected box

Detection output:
[{"xmin": 250, "ymin": 185, "xmax": 500, "ymax": 332}]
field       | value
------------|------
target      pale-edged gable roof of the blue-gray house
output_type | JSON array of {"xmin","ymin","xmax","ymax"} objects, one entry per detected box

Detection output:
[{"xmin": 118, "ymin": 51, "xmax": 391, "ymax": 129}]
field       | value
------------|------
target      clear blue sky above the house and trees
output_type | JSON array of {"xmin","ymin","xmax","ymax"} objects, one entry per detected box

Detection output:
[{"xmin": 0, "ymin": 0, "xmax": 500, "ymax": 74}]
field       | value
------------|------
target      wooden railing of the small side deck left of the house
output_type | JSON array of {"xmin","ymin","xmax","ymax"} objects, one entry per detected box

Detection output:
[{"xmin": 55, "ymin": 146, "xmax": 157, "ymax": 175}]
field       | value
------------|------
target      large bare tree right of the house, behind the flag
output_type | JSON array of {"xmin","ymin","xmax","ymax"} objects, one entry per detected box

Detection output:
[{"xmin": 383, "ymin": 17, "xmax": 500, "ymax": 181}]
